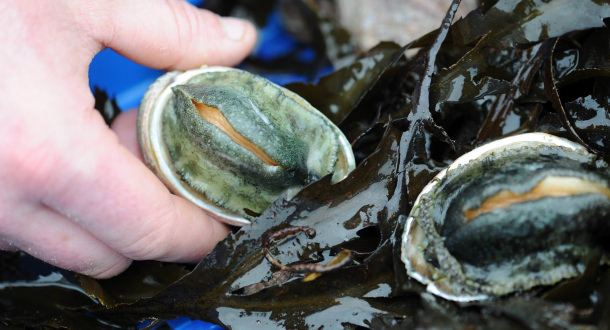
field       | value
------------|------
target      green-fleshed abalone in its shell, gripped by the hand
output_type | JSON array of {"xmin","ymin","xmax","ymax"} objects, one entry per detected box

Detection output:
[{"xmin": 138, "ymin": 67, "xmax": 355, "ymax": 225}]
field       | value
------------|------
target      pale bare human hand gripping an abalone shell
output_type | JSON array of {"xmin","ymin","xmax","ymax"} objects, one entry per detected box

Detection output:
[{"xmin": 0, "ymin": 0, "xmax": 256, "ymax": 278}]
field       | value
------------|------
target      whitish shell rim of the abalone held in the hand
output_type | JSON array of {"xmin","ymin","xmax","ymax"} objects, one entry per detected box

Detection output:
[{"xmin": 138, "ymin": 66, "xmax": 356, "ymax": 226}]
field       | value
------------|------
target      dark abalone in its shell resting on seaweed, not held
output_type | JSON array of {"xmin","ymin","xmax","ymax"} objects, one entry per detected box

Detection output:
[{"xmin": 401, "ymin": 133, "xmax": 610, "ymax": 301}]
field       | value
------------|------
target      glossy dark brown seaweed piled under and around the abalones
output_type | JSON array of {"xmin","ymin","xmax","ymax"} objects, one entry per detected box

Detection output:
[{"xmin": 0, "ymin": 0, "xmax": 610, "ymax": 329}]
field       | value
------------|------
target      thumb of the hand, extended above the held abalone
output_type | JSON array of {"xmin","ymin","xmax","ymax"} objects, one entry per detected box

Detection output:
[{"xmin": 81, "ymin": 0, "xmax": 256, "ymax": 69}]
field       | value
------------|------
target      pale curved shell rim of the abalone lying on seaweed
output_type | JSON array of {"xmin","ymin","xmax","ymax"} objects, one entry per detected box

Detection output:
[{"xmin": 401, "ymin": 132, "xmax": 589, "ymax": 303}]
